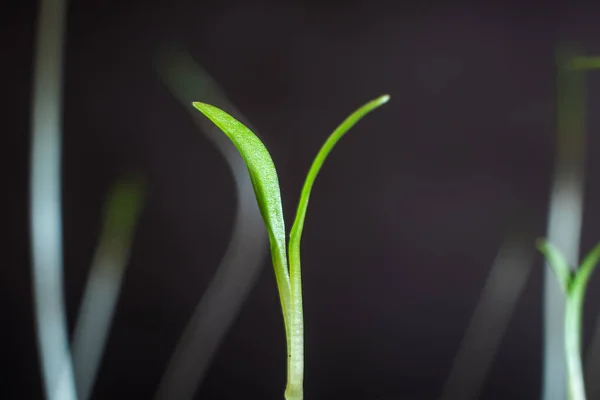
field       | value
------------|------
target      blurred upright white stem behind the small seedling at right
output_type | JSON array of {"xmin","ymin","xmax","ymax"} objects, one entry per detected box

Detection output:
[{"xmin": 542, "ymin": 45, "xmax": 585, "ymax": 400}]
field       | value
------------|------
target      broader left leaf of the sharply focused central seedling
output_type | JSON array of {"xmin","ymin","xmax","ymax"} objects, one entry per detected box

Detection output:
[{"xmin": 192, "ymin": 102, "xmax": 290, "ymax": 318}]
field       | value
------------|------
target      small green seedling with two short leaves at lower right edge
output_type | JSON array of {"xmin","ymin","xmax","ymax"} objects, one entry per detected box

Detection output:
[{"xmin": 538, "ymin": 240, "xmax": 600, "ymax": 400}]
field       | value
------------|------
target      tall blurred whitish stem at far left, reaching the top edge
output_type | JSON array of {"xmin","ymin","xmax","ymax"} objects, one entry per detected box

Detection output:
[{"xmin": 30, "ymin": 0, "xmax": 76, "ymax": 400}]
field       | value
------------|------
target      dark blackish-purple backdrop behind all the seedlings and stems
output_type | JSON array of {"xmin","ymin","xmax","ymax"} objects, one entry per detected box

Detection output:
[{"xmin": 5, "ymin": 0, "xmax": 600, "ymax": 399}]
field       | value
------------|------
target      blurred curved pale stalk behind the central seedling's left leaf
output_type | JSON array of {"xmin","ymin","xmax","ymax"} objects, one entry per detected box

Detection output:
[{"xmin": 156, "ymin": 49, "xmax": 268, "ymax": 400}]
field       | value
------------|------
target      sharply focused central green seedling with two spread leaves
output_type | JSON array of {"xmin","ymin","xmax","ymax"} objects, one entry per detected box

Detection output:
[{"xmin": 192, "ymin": 95, "xmax": 390, "ymax": 400}]
